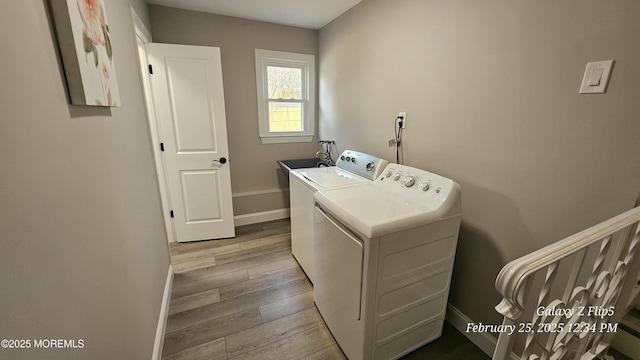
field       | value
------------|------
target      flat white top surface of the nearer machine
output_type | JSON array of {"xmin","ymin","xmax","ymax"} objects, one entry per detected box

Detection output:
[{"xmin": 314, "ymin": 183, "xmax": 440, "ymax": 238}]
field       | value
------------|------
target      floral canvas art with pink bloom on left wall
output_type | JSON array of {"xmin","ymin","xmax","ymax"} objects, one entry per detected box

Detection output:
[{"xmin": 51, "ymin": 0, "xmax": 120, "ymax": 106}]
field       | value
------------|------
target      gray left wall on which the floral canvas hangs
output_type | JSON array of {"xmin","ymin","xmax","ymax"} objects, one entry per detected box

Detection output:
[{"xmin": 0, "ymin": 0, "xmax": 170, "ymax": 360}]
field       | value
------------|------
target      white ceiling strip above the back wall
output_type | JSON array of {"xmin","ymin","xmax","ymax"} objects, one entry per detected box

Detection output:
[{"xmin": 147, "ymin": 0, "xmax": 362, "ymax": 29}]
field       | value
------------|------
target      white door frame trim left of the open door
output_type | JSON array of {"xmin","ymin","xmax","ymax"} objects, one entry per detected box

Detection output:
[{"xmin": 131, "ymin": 8, "xmax": 177, "ymax": 243}]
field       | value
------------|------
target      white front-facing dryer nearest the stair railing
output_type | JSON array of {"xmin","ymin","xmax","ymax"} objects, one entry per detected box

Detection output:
[{"xmin": 314, "ymin": 164, "xmax": 462, "ymax": 360}]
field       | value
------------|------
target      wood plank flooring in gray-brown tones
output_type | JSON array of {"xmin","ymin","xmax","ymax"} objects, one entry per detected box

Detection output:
[{"xmin": 162, "ymin": 219, "xmax": 489, "ymax": 360}]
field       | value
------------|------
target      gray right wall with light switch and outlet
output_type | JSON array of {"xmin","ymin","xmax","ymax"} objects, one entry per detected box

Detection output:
[{"xmin": 319, "ymin": 0, "xmax": 640, "ymax": 323}]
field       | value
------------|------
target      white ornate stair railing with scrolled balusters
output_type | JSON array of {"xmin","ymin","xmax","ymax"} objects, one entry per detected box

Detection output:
[{"xmin": 493, "ymin": 207, "xmax": 640, "ymax": 360}]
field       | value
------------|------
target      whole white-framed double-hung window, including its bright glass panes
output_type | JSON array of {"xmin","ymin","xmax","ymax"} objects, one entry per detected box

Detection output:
[{"xmin": 256, "ymin": 49, "xmax": 315, "ymax": 144}]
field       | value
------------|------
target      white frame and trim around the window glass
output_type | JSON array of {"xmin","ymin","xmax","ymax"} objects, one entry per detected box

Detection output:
[{"xmin": 256, "ymin": 49, "xmax": 316, "ymax": 144}]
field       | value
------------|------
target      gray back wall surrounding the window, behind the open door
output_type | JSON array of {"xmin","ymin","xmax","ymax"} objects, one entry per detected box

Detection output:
[{"xmin": 149, "ymin": 5, "xmax": 318, "ymax": 215}]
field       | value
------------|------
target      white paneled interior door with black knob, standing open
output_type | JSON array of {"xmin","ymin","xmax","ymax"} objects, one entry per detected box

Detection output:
[{"xmin": 146, "ymin": 43, "xmax": 235, "ymax": 242}]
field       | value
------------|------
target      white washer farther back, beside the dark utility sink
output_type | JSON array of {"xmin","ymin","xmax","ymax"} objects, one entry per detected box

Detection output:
[{"xmin": 289, "ymin": 150, "xmax": 388, "ymax": 282}]
